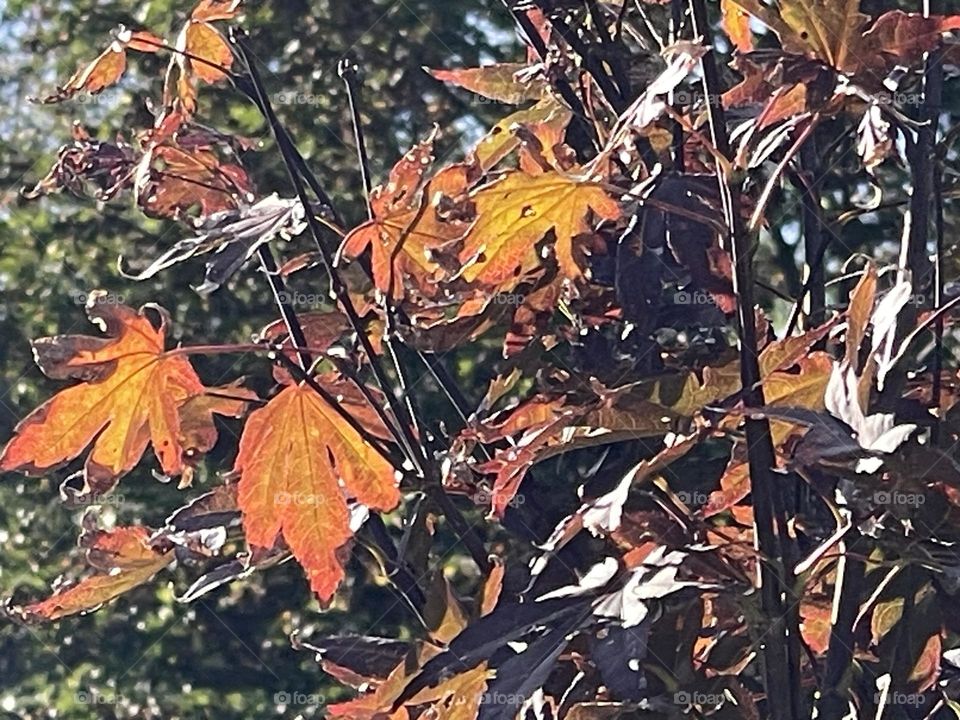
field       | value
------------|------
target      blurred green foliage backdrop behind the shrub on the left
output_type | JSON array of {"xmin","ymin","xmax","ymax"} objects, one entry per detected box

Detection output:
[{"xmin": 0, "ymin": 0, "xmax": 518, "ymax": 719}]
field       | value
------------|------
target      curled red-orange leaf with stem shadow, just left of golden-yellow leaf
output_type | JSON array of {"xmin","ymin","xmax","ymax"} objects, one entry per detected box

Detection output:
[{"xmin": 339, "ymin": 130, "xmax": 469, "ymax": 298}]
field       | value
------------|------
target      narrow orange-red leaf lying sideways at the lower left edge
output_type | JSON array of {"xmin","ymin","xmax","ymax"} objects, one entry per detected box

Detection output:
[{"xmin": 19, "ymin": 526, "xmax": 174, "ymax": 621}]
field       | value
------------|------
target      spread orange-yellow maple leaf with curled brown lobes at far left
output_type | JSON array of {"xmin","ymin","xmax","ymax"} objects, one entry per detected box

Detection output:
[{"xmin": 0, "ymin": 293, "xmax": 215, "ymax": 492}]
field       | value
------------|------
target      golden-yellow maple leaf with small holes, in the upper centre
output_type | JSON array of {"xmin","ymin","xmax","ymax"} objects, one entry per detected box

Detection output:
[{"xmin": 459, "ymin": 171, "xmax": 620, "ymax": 292}]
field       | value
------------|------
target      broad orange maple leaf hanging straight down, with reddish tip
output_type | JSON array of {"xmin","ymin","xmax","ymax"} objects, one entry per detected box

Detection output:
[{"xmin": 235, "ymin": 375, "xmax": 400, "ymax": 602}]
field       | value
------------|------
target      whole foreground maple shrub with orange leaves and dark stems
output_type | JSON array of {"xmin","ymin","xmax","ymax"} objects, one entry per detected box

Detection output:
[{"xmin": 0, "ymin": 0, "xmax": 960, "ymax": 720}]
